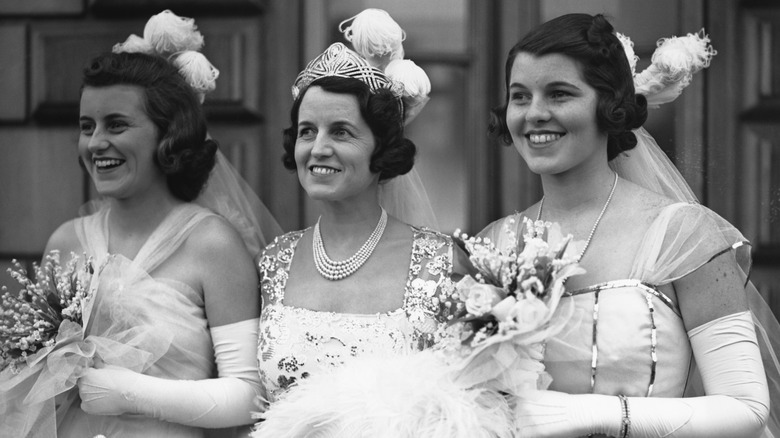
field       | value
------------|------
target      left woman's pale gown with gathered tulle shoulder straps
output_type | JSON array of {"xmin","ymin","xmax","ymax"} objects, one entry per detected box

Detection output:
[{"xmin": 58, "ymin": 204, "xmax": 215, "ymax": 438}]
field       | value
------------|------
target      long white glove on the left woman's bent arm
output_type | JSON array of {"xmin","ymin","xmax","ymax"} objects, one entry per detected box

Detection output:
[{"xmin": 78, "ymin": 318, "xmax": 261, "ymax": 428}]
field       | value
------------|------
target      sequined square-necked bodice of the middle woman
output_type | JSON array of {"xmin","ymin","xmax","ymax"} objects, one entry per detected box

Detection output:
[{"xmin": 258, "ymin": 227, "xmax": 454, "ymax": 402}]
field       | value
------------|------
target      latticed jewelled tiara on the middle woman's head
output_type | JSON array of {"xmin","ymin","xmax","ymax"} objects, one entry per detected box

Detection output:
[{"xmin": 292, "ymin": 43, "xmax": 403, "ymax": 99}]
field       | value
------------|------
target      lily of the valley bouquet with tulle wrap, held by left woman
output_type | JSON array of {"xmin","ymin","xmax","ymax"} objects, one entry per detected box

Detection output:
[{"xmin": 0, "ymin": 251, "xmax": 94, "ymax": 431}]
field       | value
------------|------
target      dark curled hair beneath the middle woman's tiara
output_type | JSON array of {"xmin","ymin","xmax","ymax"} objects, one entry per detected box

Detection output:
[{"xmin": 282, "ymin": 76, "xmax": 417, "ymax": 181}]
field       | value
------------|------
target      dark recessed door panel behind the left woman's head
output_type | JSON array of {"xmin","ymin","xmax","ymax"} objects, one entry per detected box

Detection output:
[{"xmin": 30, "ymin": 18, "xmax": 263, "ymax": 125}]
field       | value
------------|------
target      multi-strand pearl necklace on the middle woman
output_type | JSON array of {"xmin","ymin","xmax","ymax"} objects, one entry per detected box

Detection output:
[{"xmin": 312, "ymin": 208, "xmax": 387, "ymax": 281}]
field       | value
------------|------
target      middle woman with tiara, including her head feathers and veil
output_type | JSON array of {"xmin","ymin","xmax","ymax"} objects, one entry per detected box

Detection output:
[{"xmin": 253, "ymin": 9, "xmax": 488, "ymax": 437}]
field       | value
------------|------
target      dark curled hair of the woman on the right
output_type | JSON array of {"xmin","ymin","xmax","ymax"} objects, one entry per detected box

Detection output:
[{"xmin": 489, "ymin": 14, "xmax": 647, "ymax": 160}]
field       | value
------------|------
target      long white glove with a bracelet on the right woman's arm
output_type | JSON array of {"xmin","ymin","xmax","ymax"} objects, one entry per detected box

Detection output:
[{"xmin": 516, "ymin": 312, "xmax": 769, "ymax": 438}]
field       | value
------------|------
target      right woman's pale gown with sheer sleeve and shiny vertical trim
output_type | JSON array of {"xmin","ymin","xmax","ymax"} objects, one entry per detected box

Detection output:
[{"xmin": 480, "ymin": 203, "xmax": 778, "ymax": 429}]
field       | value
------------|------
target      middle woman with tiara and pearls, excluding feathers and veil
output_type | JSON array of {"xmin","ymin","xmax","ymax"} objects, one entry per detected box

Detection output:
[{"xmin": 258, "ymin": 44, "xmax": 454, "ymax": 403}]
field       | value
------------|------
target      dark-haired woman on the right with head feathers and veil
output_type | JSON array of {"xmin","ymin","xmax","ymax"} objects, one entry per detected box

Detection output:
[{"xmin": 481, "ymin": 14, "xmax": 780, "ymax": 438}]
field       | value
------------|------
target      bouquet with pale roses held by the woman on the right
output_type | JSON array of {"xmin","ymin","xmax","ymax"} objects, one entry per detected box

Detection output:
[{"xmin": 438, "ymin": 218, "xmax": 585, "ymax": 394}]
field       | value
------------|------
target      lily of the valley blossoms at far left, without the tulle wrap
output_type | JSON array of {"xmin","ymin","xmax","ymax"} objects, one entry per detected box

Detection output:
[{"xmin": 0, "ymin": 251, "xmax": 94, "ymax": 374}]
